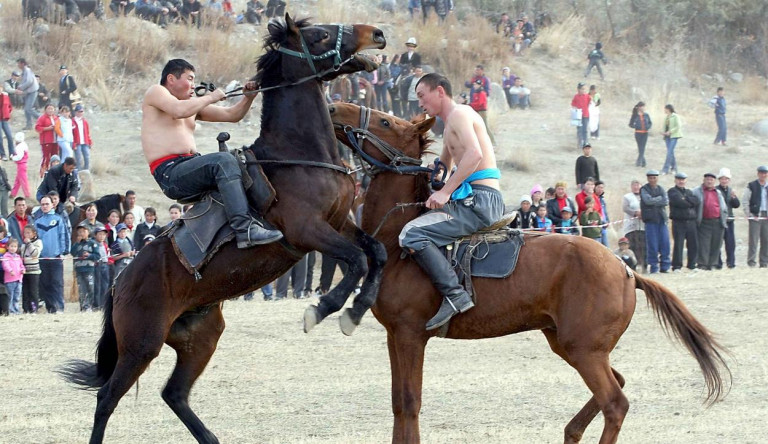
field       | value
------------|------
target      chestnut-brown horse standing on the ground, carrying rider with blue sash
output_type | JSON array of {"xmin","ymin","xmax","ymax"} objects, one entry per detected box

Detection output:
[{"xmin": 329, "ymin": 104, "xmax": 730, "ymax": 444}]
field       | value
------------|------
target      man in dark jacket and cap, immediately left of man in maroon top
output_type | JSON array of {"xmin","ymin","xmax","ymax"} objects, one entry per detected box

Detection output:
[{"xmin": 667, "ymin": 172, "xmax": 701, "ymax": 271}]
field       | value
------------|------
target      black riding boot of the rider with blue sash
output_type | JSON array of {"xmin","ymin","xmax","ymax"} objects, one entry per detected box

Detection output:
[{"xmin": 413, "ymin": 243, "xmax": 475, "ymax": 330}]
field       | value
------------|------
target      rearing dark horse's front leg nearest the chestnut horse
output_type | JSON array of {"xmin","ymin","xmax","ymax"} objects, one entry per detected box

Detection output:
[{"xmin": 339, "ymin": 223, "xmax": 387, "ymax": 336}]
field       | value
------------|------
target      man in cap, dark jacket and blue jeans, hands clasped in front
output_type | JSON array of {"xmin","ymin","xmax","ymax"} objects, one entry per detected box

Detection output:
[{"xmin": 640, "ymin": 170, "xmax": 671, "ymax": 274}]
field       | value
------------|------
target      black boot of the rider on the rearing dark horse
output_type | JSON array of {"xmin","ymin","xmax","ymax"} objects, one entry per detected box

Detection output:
[{"xmin": 218, "ymin": 179, "xmax": 283, "ymax": 248}]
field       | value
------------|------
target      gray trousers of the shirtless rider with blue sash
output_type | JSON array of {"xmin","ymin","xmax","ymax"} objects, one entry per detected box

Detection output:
[{"xmin": 399, "ymin": 185, "xmax": 504, "ymax": 251}]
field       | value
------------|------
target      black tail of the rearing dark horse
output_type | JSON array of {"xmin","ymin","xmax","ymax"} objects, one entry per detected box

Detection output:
[{"xmin": 56, "ymin": 286, "xmax": 117, "ymax": 390}]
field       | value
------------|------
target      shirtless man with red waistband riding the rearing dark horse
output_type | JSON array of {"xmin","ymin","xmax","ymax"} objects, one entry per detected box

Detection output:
[{"xmin": 141, "ymin": 59, "xmax": 283, "ymax": 248}]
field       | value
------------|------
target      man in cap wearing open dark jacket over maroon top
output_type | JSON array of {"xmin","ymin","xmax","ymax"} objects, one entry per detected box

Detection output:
[{"xmin": 693, "ymin": 173, "xmax": 728, "ymax": 270}]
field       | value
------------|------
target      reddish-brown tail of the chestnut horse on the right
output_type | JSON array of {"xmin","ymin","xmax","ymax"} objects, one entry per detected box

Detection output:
[{"xmin": 635, "ymin": 274, "xmax": 731, "ymax": 405}]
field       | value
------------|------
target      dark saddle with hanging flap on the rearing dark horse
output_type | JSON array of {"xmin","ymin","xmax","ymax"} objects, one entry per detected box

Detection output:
[{"xmin": 160, "ymin": 147, "xmax": 276, "ymax": 280}]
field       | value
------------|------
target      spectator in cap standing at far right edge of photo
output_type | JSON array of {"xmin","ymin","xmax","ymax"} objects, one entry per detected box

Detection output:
[{"xmin": 741, "ymin": 165, "xmax": 768, "ymax": 268}]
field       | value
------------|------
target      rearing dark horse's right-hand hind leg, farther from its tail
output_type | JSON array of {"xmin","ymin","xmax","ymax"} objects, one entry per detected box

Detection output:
[{"xmin": 162, "ymin": 304, "xmax": 224, "ymax": 443}]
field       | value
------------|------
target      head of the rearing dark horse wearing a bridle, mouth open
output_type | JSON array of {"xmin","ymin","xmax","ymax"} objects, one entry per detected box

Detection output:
[{"xmin": 256, "ymin": 13, "xmax": 387, "ymax": 86}]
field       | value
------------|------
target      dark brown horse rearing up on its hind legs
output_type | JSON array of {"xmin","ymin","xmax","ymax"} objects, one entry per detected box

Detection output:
[{"xmin": 60, "ymin": 14, "xmax": 386, "ymax": 443}]
